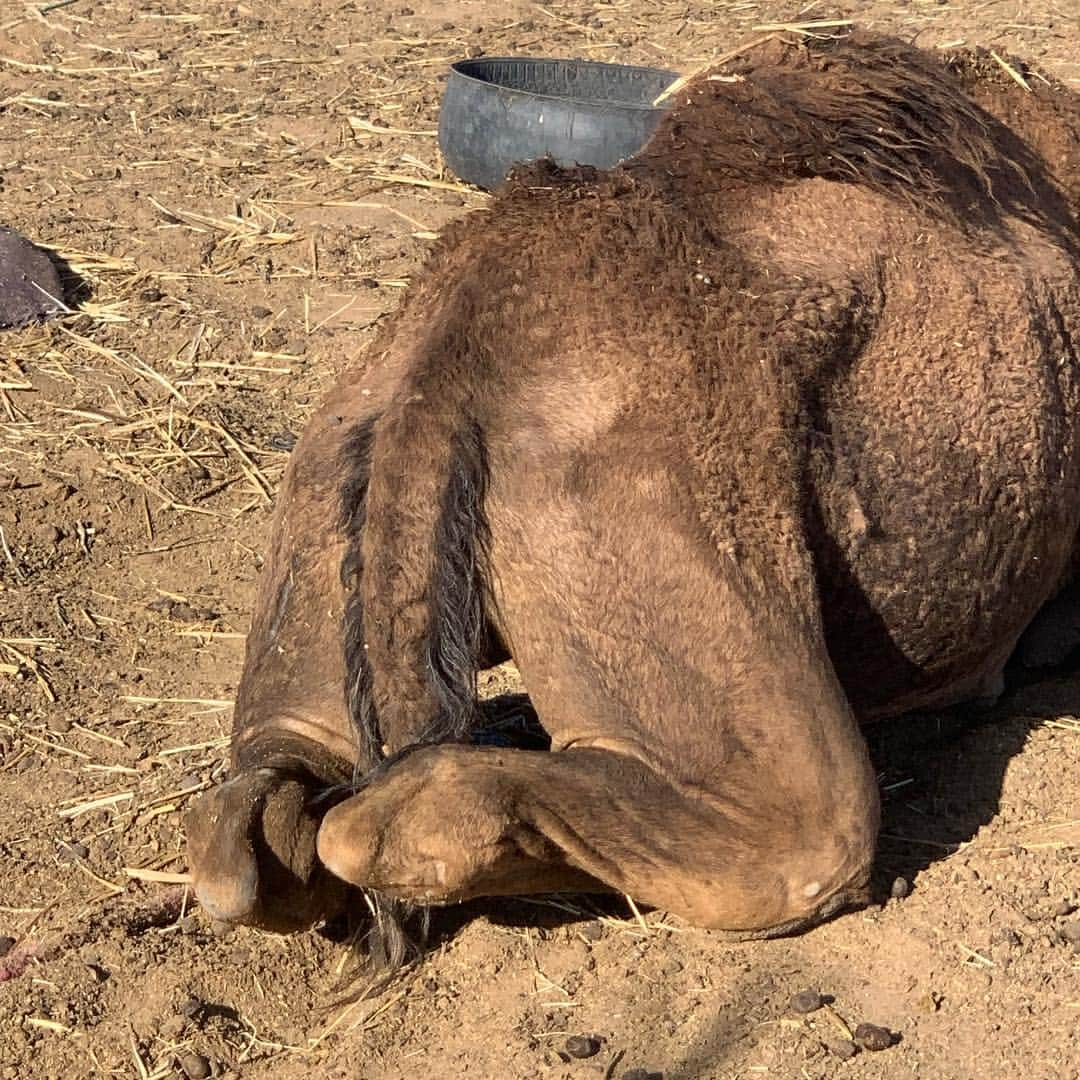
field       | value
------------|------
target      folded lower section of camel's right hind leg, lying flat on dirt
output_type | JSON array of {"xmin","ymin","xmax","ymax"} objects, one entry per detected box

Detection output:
[{"xmin": 319, "ymin": 745, "xmax": 876, "ymax": 933}]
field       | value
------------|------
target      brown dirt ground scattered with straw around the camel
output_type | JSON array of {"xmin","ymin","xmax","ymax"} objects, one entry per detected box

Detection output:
[{"xmin": 0, "ymin": 0, "xmax": 1080, "ymax": 1080}]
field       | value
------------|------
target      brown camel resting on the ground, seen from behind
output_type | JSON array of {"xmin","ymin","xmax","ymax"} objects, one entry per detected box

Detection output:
[{"xmin": 188, "ymin": 35, "xmax": 1080, "ymax": 967}]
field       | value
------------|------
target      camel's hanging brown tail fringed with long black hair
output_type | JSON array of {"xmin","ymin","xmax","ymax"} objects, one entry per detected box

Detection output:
[{"xmin": 334, "ymin": 302, "xmax": 490, "ymax": 978}]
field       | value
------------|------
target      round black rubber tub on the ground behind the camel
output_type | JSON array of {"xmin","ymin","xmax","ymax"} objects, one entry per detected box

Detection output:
[{"xmin": 438, "ymin": 57, "xmax": 677, "ymax": 188}]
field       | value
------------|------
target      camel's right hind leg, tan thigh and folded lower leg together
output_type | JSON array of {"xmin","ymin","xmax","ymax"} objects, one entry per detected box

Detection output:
[{"xmin": 319, "ymin": 451, "xmax": 877, "ymax": 933}]
